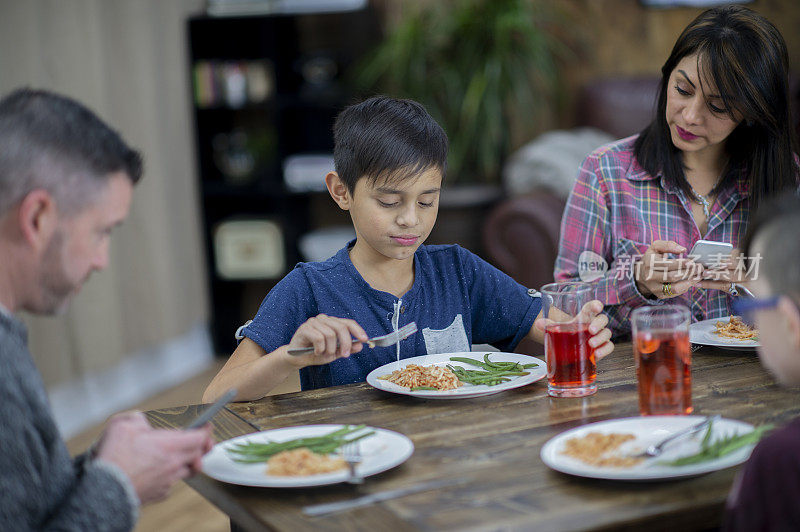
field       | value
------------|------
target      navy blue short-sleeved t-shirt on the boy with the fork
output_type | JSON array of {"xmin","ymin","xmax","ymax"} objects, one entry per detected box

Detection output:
[{"xmin": 241, "ymin": 242, "xmax": 542, "ymax": 390}]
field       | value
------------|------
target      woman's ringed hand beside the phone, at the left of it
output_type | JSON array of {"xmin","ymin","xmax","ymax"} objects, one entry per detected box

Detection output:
[{"xmin": 633, "ymin": 240, "xmax": 703, "ymax": 299}]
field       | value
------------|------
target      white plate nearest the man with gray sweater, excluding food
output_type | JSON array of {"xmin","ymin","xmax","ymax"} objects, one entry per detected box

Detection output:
[{"xmin": 203, "ymin": 425, "xmax": 414, "ymax": 488}]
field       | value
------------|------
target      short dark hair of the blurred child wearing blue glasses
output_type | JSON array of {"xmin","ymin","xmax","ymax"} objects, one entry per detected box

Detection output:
[{"xmin": 742, "ymin": 193, "xmax": 800, "ymax": 304}]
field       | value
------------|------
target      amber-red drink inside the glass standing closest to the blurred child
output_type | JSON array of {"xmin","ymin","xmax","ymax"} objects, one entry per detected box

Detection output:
[{"xmin": 633, "ymin": 330, "xmax": 693, "ymax": 416}]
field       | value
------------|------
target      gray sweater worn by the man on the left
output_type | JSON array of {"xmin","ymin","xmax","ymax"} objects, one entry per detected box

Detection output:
[{"xmin": 0, "ymin": 309, "xmax": 138, "ymax": 531}]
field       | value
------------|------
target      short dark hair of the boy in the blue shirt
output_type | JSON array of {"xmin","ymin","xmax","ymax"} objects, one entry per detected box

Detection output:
[{"xmin": 333, "ymin": 96, "xmax": 447, "ymax": 193}]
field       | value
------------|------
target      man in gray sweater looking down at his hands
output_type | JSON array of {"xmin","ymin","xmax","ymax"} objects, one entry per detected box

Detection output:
[{"xmin": 0, "ymin": 89, "xmax": 213, "ymax": 530}]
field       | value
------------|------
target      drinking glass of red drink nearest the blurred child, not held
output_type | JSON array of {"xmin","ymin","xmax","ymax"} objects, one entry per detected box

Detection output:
[{"xmin": 631, "ymin": 305, "xmax": 692, "ymax": 416}]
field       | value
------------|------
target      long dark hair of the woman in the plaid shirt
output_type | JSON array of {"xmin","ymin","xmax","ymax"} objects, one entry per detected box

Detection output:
[{"xmin": 634, "ymin": 5, "xmax": 798, "ymax": 209}]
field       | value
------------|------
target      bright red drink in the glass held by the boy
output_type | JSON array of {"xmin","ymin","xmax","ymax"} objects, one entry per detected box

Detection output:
[{"xmin": 544, "ymin": 323, "xmax": 597, "ymax": 397}]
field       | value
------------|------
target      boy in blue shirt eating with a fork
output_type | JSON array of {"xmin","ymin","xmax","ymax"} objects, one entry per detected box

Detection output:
[{"xmin": 203, "ymin": 96, "xmax": 613, "ymax": 401}]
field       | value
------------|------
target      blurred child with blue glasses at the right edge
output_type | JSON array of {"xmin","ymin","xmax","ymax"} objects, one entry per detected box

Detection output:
[{"xmin": 723, "ymin": 195, "xmax": 800, "ymax": 531}]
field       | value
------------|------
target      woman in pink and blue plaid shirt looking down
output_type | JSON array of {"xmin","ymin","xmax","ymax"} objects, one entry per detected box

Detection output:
[{"xmin": 555, "ymin": 6, "xmax": 798, "ymax": 336}]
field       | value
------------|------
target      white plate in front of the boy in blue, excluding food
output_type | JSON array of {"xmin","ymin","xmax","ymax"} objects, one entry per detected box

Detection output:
[{"xmin": 367, "ymin": 351, "xmax": 547, "ymax": 399}]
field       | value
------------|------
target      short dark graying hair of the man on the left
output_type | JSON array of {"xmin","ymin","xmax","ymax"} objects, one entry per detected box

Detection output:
[{"xmin": 0, "ymin": 88, "xmax": 142, "ymax": 215}]
